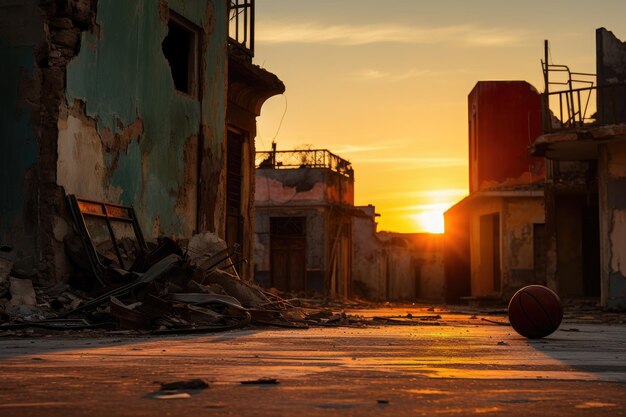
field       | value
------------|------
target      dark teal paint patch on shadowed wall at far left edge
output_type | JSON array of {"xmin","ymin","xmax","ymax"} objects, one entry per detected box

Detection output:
[{"xmin": 0, "ymin": 38, "xmax": 37, "ymax": 246}]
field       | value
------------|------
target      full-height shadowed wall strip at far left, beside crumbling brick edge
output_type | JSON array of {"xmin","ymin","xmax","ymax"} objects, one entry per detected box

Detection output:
[{"xmin": 0, "ymin": 0, "xmax": 44, "ymax": 258}]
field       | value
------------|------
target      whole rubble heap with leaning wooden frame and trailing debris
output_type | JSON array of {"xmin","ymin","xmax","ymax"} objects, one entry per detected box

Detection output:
[{"xmin": 0, "ymin": 195, "xmax": 441, "ymax": 334}]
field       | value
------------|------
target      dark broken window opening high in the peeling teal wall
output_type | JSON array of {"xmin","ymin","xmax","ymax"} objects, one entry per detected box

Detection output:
[{"xmin": 161, "ymin": 11, "xmax": 200, "ymax": 96}]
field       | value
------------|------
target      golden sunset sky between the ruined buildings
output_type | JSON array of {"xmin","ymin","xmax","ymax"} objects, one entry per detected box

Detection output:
[{"xmin": 255, "ymin": 0, "xmax": 626, "ymax": 232}]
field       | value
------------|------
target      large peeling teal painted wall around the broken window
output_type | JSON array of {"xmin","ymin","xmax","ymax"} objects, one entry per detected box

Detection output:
[{"xmin": 66, "ymin": 0, "xmax": 227, "ymax": 236}]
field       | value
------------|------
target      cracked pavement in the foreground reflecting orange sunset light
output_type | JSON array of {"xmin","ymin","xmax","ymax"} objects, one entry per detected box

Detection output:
[{"xmin": 0, "ymin": 309, "xmax": 626, "ymax": 417}]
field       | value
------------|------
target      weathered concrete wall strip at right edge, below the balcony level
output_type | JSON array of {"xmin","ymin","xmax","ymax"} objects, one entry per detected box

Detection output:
[{"xmin": 598, "ymin": 142, "xmax": 626, "ymax": 310}]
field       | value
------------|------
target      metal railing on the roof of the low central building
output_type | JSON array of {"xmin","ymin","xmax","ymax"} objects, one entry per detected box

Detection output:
[{"xmin": 255, "ymin": 149, "xmax": 354, "ymax": 179}]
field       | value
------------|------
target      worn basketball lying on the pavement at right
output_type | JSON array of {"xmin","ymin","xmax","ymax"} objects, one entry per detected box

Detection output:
[{"xmin": 508, "ymin": 285, "xmax": 563, "ymax": 339}]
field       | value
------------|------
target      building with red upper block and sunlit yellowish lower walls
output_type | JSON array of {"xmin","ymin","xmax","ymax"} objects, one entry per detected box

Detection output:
[{"xmin": 444, "ymin": 81, "xmax": 546, "ymax": 303}]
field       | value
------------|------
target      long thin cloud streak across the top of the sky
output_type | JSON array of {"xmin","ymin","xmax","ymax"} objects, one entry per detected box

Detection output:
[{"xmin": 255, "ymin": 21, "xmax": 530, "ymax": 47}]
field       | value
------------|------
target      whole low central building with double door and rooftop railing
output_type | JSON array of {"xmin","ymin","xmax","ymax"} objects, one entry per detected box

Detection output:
[{"xmin": 254, "ymin": 149, "xmax": 358, "ymax": 297}]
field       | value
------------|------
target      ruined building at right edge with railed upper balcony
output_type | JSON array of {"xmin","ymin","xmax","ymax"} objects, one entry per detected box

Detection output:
[{"xmin": 532, "ymin": 28, "xmax": 626, "ymax": 309}]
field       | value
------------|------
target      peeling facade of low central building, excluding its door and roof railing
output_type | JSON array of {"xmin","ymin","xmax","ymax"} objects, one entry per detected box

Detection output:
[{"xmin": 254, "ymin": 168, "xmax": 354, "ymax": 295}]
